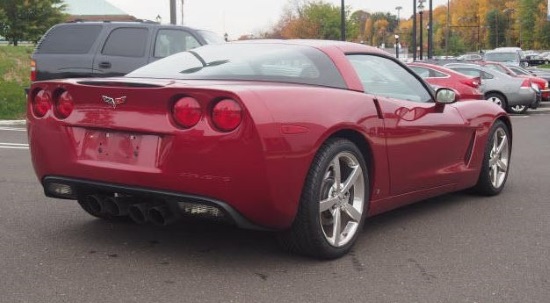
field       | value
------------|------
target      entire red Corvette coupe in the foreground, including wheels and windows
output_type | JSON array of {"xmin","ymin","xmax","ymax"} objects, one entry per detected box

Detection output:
[{"xmin": 27, "ymin": 40, "xmax": 512, "ymax": 258}]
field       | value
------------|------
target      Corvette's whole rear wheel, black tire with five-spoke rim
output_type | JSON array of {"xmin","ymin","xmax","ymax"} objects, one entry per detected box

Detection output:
[{"xmin": 279, "ymin": 138, "xmax": 370, "ymax": 259}]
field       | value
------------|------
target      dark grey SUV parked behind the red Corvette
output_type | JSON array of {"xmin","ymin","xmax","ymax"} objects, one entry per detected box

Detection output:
[{"xmin": 31, "ymin": 21, "xmax": 224, "ymax": 81}]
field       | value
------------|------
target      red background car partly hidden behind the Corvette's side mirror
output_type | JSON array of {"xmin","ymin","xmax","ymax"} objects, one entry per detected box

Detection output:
[{"xmin": 408, "ymin": 62, "xmax": 484, "ymax": 100}]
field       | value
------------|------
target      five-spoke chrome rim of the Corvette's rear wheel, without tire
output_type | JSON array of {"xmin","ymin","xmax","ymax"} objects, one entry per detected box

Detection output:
[{"xmin": 319, "ymin": 152, "xmax": 365, "ymax": 247}]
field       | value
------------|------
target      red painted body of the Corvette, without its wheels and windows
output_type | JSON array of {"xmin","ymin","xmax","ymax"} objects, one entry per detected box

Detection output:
[{"xmin": 27, "ymin": 41, "xmax": 511, "ymax": 258}]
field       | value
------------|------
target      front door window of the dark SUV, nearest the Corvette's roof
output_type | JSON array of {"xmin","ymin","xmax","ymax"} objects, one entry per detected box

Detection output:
[{"xmin": 153, "ymin": 29, "xmax": 200, "ymax": 58}]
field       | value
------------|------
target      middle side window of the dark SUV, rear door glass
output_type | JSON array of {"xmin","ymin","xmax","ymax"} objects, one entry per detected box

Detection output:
[{"xmin": 101, "ymin": 27, "xmax": 149, "ymax": 57}]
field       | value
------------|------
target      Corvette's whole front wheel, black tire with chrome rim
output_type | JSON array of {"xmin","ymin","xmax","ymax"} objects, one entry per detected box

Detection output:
[{"xmin": 472, "ymin": 120, "xmax": 512, "ymax": 196}]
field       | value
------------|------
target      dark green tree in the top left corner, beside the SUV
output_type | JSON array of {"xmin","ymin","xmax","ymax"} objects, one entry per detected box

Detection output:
[{"xmin": 0, "ymin": 0, "xmax": 66, "ymax": 46}]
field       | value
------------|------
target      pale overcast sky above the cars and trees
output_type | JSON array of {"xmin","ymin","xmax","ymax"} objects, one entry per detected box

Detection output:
[{"xmin": 107, "ymin": 0, "xmax": 447, "ymax": 39}]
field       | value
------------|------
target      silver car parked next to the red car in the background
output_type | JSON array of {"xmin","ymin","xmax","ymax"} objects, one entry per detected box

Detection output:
[{"xmin": 445, "ymin": 63, "xmax": 540, "ymax": 114}]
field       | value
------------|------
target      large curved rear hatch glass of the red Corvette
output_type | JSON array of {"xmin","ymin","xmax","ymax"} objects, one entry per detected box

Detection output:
[{"xmin": 126, "ymin": 43, "xmax": 346, "ymax": 88}]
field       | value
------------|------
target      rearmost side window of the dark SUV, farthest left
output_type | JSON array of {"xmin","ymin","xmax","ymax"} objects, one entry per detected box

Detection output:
[{"xmin": 36, "ymin": 24, "xmax": 102, "ymax": 54}]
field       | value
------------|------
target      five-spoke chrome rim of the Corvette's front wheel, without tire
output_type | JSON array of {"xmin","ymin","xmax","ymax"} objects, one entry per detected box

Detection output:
[{"xmin": 489, "ymin": 128, "xmax": 510, "ymax": 188}]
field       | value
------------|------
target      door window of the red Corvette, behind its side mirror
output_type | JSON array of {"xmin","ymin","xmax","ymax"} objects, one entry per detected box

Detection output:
[{"xmin": 347, "ymin": 55, "xmax": 432, "ymax": 102}]
